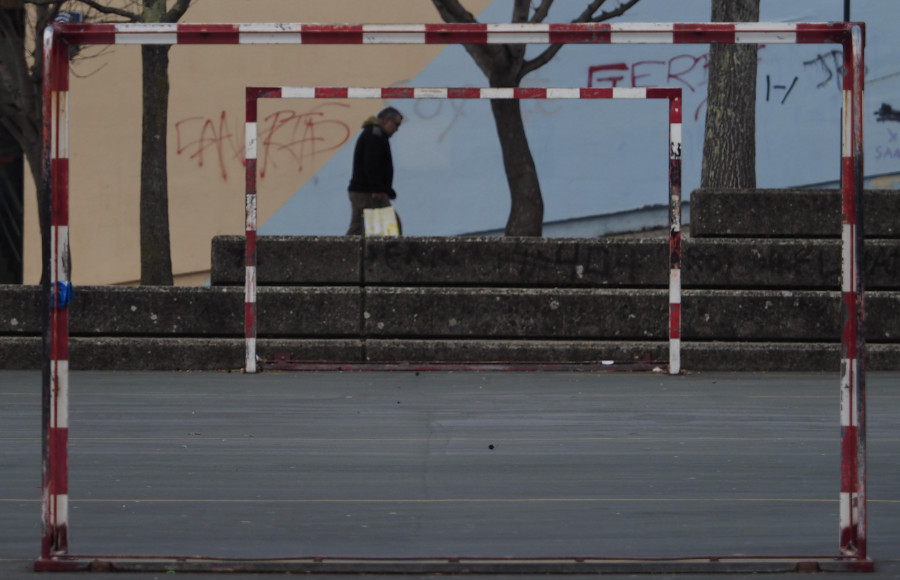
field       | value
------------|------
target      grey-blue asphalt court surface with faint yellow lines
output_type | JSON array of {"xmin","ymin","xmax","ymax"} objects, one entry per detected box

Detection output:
[{"xmin": 0, "ymin": 371, "xmax": 900, "ymax": 579}]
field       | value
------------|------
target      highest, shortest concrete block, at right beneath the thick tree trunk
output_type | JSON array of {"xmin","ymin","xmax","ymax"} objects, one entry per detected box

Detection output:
[{"xmin": 691, "ymin": 189, "xmax": 900, "ymax": 238}]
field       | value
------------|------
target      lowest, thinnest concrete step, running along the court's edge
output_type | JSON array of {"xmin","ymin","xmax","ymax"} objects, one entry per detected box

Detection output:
[{"xmin": 0, "ymin": 336, "xmax": 900, "ymax": 372}]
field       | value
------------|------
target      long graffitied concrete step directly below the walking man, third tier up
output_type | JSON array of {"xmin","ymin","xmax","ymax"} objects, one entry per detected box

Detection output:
[{"xmin": 211, "ymin": 236, "xmax": 900, "ymax": 290}]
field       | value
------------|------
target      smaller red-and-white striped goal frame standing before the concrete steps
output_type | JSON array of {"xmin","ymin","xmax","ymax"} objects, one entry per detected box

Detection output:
[{"xmin": 244, "ymin": 87, "xmax": 682, "ymax": 375}]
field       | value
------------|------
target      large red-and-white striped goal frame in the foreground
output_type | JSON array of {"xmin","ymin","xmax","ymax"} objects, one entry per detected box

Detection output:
[{"xmin": 35, "ymin": 22, "xmax": 872, "ymax": 571}]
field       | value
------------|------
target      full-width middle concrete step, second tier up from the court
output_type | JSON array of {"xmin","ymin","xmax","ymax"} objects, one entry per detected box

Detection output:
[{"xmin": 7, "ymin": 286, "xmax": 900, "ymax": 342}]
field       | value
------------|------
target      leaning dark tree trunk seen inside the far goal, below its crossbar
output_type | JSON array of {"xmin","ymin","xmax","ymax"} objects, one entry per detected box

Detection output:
[{"xmin": 491, "ymin": 99, "xmax": 544, "ymax": 236}]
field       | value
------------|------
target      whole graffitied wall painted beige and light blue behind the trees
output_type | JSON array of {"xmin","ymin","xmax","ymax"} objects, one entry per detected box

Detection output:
[{"xmin": 26, "ymin": 0, "xmax": 900, "ymax": 284}]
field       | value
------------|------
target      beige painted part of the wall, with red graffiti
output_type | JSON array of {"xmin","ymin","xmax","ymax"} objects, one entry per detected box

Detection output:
[{"xmin": 24, "ymin": 0, "xmax": 490, "ymax": 285}]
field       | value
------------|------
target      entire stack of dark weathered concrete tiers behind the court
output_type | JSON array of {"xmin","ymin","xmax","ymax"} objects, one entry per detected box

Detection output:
[{"xmin": 0, "ymin": 190, "xmax": 900, "ymax": 372}]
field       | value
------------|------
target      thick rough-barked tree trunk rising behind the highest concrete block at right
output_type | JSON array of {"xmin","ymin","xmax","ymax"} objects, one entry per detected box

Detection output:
[{"xmin": 700, "ymin": 0, "xmax": 760, "ymax": 188}]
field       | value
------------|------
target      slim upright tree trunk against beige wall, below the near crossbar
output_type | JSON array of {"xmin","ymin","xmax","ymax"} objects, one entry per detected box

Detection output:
[{"xmin": 140, "ymin": 45, "xmax": 172, "ymax": 286}]
